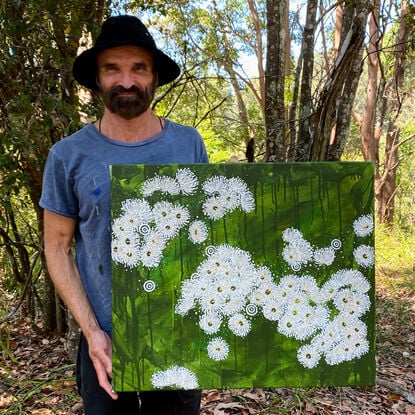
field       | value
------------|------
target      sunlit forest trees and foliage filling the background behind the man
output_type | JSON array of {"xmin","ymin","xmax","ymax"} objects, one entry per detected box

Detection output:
[{"xmin": 0, "ymin": 0, "xmax": 415, "ymax": 333}]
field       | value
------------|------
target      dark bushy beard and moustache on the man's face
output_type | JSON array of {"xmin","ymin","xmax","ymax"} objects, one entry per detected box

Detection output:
[{"xmin": 101, "ymin": 83, "xmax": 156, "ymax": 120}]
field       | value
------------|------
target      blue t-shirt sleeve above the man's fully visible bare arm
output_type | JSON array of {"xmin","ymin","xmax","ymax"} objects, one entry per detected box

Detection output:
[{"xmin": 39, "ymin": 148, "xmax": 78, "ymax": 218}]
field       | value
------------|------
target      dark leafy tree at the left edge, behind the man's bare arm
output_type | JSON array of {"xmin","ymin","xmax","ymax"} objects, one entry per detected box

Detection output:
[{"xmin": 0, "ymin": 0, "xmax": 105, "ymax": 331}]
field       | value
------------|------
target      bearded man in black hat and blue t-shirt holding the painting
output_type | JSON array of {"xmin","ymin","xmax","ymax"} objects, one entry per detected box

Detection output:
[{"xmin": 40, "ymin": 16, "xmax": 208, "ymax": 415}]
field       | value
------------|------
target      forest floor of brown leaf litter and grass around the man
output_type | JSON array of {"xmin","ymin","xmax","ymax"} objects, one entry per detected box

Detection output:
[{"xmin": 0, "ymin": 269, "xmax": 415, "ymax": 415}]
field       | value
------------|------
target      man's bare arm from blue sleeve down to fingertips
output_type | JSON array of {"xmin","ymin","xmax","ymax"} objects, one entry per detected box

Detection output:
[{"xmin": 44, "ymin": 210, "xmax": 118, "ymax": 399}]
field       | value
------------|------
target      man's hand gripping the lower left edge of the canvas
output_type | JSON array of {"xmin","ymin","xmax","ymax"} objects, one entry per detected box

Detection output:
[{"xmin": 87, "ymin": 330, "xmax": 118, "ymax": 399}]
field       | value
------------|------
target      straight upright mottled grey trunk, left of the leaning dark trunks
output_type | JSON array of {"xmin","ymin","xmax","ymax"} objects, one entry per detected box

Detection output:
[{"xmin": 265, "ymin": 0, "xmax": 288, "ymax": 162}]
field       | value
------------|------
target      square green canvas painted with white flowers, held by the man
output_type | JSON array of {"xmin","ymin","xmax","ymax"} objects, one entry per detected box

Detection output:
[{"xmin": 111, "ymin": 162, "xmax": 375, "ymax": 391}]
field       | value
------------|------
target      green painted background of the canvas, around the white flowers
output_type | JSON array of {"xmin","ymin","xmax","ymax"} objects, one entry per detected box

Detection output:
[{"xmin": 111, "ymin": 162, "xmax": 375, "ymax": 391}]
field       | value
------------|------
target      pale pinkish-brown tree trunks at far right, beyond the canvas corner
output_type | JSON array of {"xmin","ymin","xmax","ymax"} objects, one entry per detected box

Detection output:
[{"xmin": 355, "ymin": 0, "xmax": 415, "ymax": 225}]
